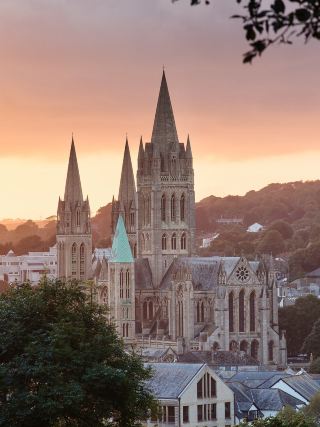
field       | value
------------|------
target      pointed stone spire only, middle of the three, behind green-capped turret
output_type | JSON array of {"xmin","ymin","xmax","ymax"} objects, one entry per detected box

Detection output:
[{"xmin": 118, "ymin": 138, "xmax": 136, "ymax": 207}]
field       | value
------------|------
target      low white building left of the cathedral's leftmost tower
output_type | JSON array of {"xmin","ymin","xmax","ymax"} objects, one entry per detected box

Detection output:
[{"xmin": 0, "ymin": 246, "xmax": 57, "ymax": 284}]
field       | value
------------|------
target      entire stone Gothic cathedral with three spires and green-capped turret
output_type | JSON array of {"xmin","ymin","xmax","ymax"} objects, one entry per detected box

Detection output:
[{"xmin": 57, "ymin": 72, "xmax": 286, "ymax": 365}]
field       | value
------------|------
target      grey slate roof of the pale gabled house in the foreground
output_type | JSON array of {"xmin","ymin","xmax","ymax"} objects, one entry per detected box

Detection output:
[{"xmin": 145, "ymin": 363, "xmax": 204, "ymax": 399}]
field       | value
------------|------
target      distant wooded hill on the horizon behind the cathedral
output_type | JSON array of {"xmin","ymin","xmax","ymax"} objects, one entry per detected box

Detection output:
[{"xmin": 0, "ymin": 181, "xmax": 320, "ymax": 278}]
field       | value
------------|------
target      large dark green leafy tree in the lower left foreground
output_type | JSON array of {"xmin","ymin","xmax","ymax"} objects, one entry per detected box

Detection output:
[{"xmin": 0, "ymin": 280, "xmax": 154, "ymax": 427}]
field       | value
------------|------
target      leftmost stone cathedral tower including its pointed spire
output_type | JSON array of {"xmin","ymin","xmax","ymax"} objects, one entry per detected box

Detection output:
[{"xmin": 57, "ymin": 138, "xmax": 92, "ymax": 280}]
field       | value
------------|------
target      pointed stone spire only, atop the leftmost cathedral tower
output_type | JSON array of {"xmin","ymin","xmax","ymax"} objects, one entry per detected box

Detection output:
[{"xmin": 64, "ymin": 134, "xmax": 83, "ymax": 203}]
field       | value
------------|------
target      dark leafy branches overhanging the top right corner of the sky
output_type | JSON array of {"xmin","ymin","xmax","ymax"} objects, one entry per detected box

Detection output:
[{"xmin": 172, "ymin": 0, "xmax": 320, "ymax": 63}]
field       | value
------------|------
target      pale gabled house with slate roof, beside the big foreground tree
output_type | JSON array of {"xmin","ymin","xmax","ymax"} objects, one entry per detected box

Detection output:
[{"xmin": 144, "ymin": 363, "xmax": 234, "ymax": 427}]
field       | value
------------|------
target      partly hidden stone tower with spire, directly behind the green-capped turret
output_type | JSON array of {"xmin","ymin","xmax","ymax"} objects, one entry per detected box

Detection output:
[{"xmin": 111, "ymin": 139, "xmax": 137, "ymax": 257}]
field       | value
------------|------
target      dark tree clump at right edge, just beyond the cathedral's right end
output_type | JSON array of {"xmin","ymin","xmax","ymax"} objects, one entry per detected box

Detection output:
[{"xmin": 279, "ymin": 295, "xmax": 320, "ymax": 356}]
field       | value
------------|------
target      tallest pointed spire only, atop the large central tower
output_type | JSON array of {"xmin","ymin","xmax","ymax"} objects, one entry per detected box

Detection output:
[{"xmin": 151, "ymin": 70, "xmax": 179, "ymax": 144}]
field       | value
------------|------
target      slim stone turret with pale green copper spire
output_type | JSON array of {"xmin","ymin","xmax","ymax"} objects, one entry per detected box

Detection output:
[{"xmin": 108, "ymin": 214, "xmax": 135, "ymax": 340}]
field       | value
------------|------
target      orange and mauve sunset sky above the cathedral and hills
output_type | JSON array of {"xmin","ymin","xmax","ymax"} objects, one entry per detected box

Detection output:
[{"xmin": 0, "ymin": 0, "xmax": 320, "ymax": 219}]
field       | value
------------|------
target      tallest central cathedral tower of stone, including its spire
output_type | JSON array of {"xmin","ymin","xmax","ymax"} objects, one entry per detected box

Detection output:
[{"xmin": 137, "ymin": 72, "xmax": 195, "ymax": 287}]
